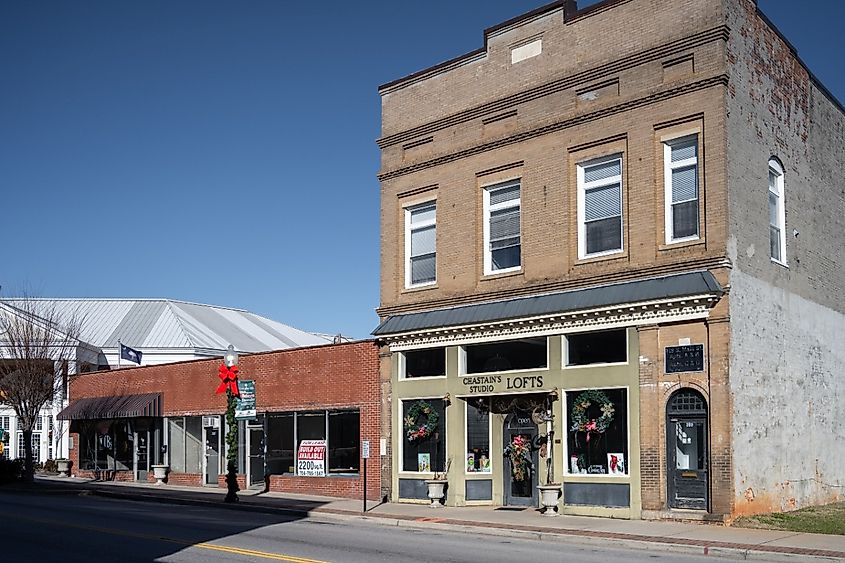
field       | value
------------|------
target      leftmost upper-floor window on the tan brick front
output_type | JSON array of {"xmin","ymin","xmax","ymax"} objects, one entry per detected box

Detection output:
[{"xmin": 405, "ymin": 201, "xmax": 437, "ymax": 287}]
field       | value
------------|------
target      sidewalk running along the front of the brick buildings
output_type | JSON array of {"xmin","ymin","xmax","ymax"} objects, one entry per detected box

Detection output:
[{"xmin": 29, "ymin": 476, "xmax": 845, "ymax": 562}]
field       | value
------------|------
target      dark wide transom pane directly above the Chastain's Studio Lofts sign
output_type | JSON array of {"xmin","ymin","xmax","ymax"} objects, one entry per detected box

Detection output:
[{"xmin": 464, "ymin": 337, "xmax": 548, "ymax": 373}]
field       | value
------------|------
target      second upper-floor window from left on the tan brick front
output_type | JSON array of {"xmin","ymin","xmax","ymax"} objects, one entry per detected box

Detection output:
[{"xmin": 484, "ymin": 181, "xmax": 522, "ymax": 274}]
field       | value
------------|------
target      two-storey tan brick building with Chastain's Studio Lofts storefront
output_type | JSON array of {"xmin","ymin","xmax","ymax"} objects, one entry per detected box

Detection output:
[{"xmin": 374, "ymin": 0, "xmax": 845, "ymax": 519}]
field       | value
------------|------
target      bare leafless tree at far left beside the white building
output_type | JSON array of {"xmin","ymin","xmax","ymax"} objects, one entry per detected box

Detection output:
[{"xmin": 0, "ymin": 296, "xmax": 85, "ymax": 481}]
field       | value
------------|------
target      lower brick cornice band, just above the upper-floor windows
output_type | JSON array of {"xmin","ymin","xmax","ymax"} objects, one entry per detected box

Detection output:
[{"xmin": 378, "ymin": 74, "xmax": 728, "ymax": 181}]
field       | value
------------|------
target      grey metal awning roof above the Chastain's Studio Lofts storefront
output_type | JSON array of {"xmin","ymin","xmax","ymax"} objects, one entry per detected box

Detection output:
[{"xmin": 373, "ymin": 271, "xmax": 722, "ymax": 336}]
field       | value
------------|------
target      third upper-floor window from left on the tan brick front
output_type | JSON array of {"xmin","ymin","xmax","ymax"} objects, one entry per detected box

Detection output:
[{"xmin": 578, "ymin": 155, "xmax": 622, "ymax": 258}]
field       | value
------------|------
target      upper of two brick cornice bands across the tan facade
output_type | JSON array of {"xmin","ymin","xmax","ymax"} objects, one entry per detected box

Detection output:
[{"xmin": 376, "ymin": 25, "xmax": 730, "ymax": 149}]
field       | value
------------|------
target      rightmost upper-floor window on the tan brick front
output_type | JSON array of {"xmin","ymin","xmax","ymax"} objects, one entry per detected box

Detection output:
[{"xmin": 663, "ymin": 135, "xmax": 699, "ymax": 244}]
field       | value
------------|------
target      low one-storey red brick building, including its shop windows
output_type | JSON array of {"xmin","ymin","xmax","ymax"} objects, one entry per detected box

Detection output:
[{"xmin": 60, "ymin": 341, "xmax": 381, "ymax": 499}]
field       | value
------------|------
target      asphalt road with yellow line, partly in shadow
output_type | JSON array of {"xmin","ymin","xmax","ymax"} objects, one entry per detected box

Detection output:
[{"xmin": 0, "ymin": 491, "xmax": 764, "ymax": 563}]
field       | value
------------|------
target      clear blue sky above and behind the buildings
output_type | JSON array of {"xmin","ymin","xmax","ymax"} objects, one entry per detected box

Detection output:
[{"xmin": 0, "ymin": 0, "xmax": 845, "ymax": 337}]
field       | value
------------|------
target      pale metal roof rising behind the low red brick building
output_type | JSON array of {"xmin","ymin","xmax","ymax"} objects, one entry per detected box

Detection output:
[{"xmin": 3, "ymin": 298, "xmax": 331, "ymax": 352}]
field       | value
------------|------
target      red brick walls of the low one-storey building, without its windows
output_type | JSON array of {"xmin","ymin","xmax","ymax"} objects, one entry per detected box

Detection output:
[{"xmin": 64, "ymin": 341, "xmax": 381, "ymax": 499}]
